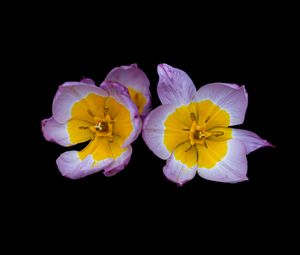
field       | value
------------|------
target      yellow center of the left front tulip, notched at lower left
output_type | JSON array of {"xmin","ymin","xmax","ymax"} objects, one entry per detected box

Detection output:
[{"xmin": 67, "ymin": 93, "xmax": 134, "ymax": 162}]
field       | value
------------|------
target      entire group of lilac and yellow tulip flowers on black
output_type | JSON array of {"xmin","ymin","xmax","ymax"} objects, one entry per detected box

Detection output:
[{"xmin": 42, "ymin": 64, "xmax": 272, "ymax": 185}]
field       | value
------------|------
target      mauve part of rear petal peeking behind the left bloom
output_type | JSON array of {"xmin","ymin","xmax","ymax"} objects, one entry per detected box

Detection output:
[{"xmin": 105, "ymin": 64, "xmax": 151, "ymax": 116}]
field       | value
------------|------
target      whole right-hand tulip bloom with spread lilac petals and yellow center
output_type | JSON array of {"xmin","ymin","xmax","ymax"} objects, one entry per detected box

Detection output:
[{"xmin": 143, "ymin": 64, "xmax": 271, "ymax": 185}]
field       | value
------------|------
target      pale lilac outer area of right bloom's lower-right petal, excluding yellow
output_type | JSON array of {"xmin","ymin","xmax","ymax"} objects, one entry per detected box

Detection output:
[{"xmin": 198, "ymin": 139, "xmax": 248, "ymax": 183}]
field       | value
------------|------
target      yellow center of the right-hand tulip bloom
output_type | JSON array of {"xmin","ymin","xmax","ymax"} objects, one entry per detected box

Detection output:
[{"xmin": 164, "ymin": 100, "xmax": 232, "ymax": 169}]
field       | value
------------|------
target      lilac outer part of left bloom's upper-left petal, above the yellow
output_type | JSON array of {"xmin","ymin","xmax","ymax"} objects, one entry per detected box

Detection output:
[{"xmin": 52, "ymin": 82, "xmax": 108, "ymax": 124}]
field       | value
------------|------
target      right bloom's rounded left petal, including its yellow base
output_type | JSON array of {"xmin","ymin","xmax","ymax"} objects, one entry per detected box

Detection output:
[{"xmin": 142, "ymin": 104, "xmax": 189, "ymax": 159}]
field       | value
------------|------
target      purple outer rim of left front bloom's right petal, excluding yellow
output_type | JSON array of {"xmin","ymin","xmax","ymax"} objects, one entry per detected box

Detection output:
[{"xmin": 101, "ymin": 81, "xmax": 142, "ymax": 148}]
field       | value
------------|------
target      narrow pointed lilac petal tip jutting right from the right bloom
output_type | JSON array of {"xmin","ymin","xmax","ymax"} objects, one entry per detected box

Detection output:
[{"xmin": 232, "ymin": 128, "xmax": 274, "ymax": 154}]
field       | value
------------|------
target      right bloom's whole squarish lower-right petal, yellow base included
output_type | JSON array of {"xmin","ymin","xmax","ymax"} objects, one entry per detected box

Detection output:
[{"xmin": 197, "ymin": 139, "xmax": 248, "ymax": 183}]
